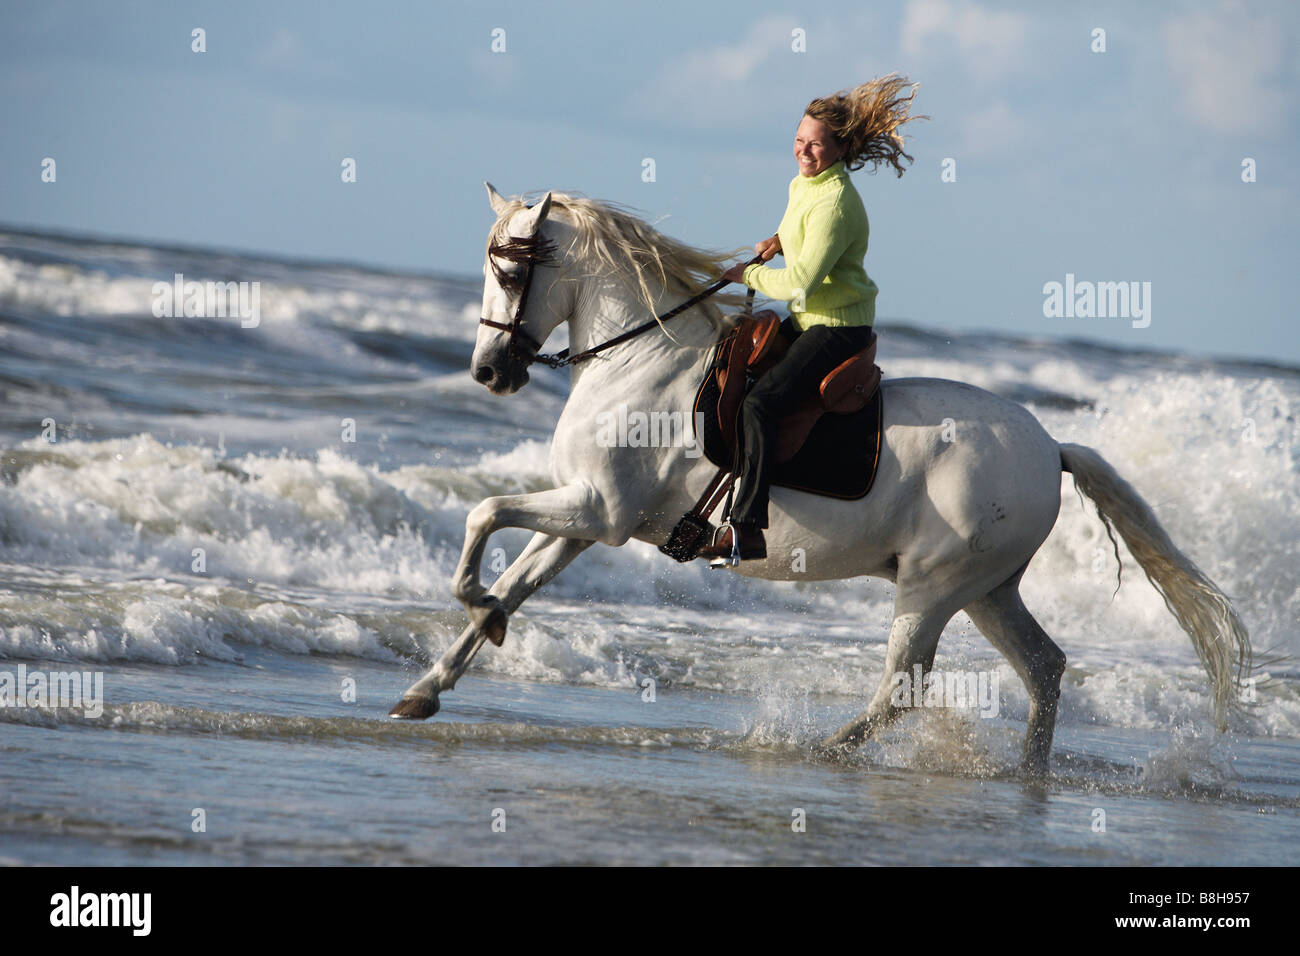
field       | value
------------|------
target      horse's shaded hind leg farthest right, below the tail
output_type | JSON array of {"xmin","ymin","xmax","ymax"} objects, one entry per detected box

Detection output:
[{"xmin": 965, "ymin": 574, "xmax": 1066, "ymax": 777}]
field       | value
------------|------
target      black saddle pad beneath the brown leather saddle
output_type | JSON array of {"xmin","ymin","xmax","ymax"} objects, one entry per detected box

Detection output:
[{"xmin": 692, "ymin": 353, "xmax": 884, "ymax": 499}]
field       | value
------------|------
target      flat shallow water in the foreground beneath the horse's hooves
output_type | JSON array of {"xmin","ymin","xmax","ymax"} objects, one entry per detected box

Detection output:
[{"xmin": 0, "ymin": 652, "xmax": 1300, "ymax": 865}]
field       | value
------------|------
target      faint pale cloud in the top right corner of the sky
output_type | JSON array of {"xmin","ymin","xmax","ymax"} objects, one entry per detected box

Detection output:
[{"xmin": 1160, "ymin": 3, "xmax": 1296, "ymax": 135}]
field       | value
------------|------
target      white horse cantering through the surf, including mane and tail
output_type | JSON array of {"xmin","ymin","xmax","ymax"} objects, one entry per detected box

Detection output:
[{"xmin": 391, "ymin": 183, "xmax": 1251, "ymax": 774}]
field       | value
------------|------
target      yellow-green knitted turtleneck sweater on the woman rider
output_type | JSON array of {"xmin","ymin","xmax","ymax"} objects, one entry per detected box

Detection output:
[{"xmin": 744, "ymin": 160, "xmax": 878, "ymax": 330}]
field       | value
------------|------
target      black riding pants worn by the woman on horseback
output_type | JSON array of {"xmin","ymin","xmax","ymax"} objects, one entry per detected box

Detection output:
[{"xmin": 732, "ymin": 316, "xmax": 871, "ymax": 528}]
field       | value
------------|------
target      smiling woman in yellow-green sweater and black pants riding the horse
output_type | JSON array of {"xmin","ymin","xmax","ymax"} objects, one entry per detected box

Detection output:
[{"xmin": 699, "ymin": 74, "xmax": 926, "ymax": 561}]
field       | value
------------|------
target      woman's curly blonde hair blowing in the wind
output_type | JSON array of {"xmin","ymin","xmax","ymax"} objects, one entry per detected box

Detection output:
[{"xmin": 803, "ymin": 73, "xmax": 930, "ymax": 176}]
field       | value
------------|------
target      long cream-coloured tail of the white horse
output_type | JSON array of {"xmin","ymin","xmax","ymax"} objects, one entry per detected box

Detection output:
[{"xmin": 1060, "ymin": 444, "xmax": 1253, "ymax": 731}]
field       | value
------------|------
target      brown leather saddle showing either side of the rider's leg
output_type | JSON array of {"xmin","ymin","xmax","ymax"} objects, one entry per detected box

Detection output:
[{"xmin": 711, "ymin": 310, "xmax": 880, "ymax": 464}]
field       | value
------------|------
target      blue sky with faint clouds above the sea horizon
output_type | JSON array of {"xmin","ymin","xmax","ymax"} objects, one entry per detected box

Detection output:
[{"xmin": 0, "ymin": 0, "xmax": 1300, "ymax": 364}]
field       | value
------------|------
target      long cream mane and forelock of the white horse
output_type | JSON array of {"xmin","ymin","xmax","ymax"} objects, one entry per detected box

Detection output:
[{"xmin": 486, "ymin": 191, "xmax": 745, "ymax": 328}]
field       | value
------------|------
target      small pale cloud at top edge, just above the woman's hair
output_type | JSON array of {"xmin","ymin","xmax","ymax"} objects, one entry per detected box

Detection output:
[{"xmin": 901, "ymin": 0, "xmax": 1030, "ymax": 82}]
